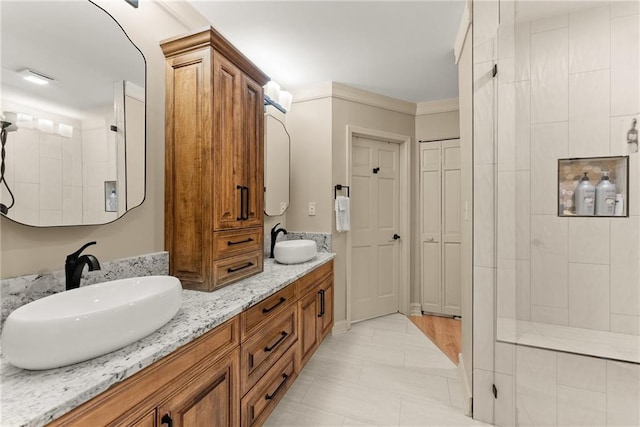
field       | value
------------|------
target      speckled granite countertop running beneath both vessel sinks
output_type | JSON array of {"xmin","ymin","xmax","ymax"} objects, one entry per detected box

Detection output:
[{"xmin": 0, "ymin": 252, "xmax": 334, "ymax": 427}]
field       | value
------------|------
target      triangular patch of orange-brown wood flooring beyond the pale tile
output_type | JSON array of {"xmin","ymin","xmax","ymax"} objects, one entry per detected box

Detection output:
[{"xmin": 409, "ymin": 314, "xmax": 462, "ymax": 365}]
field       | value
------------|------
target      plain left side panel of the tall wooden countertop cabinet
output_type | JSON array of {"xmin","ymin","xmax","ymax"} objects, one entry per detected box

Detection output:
[{"xmin": 165, "ymin": 49, "xmax": 212, "ymax": 289}]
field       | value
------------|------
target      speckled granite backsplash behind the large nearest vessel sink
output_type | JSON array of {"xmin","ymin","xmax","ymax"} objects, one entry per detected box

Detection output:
[{"xmin": 0, "ymin": 252, "xmax": 169, "ymax": 331}]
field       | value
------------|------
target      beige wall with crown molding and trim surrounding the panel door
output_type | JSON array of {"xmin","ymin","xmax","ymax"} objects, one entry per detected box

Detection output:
[{"xmin": 287, "ymin": 84, "xmax": 459, "ymax": 322}]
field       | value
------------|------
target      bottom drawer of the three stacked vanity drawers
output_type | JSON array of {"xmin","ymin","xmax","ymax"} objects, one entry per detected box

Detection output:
[{"xmin": 241, "ymin": 346, "xmax": 297, "ymax": 427}]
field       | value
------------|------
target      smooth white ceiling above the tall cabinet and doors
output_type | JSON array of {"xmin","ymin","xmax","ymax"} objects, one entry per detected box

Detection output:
[{"xmin": 190, "ymin": 0, "xmax": 465, "ymax": 102}]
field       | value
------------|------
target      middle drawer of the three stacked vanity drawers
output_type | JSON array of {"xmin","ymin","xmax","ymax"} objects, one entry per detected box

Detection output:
[{"xmin": 240, "ymin": 304, "xmax": 298, "ymax": 394}]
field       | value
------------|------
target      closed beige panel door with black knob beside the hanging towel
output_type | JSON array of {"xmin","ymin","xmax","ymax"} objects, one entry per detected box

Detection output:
[{"xmin": 351, "ymin": 137, "xmax": 400, "ymax": 322}]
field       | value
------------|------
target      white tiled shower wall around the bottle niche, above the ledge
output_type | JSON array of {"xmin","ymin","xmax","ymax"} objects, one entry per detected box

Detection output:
[{"xmin": 497, "ymin": 2, "xmax": 640, "ymax": 335}]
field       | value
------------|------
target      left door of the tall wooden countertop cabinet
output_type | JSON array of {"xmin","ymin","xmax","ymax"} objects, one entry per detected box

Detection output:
[{"xmin": 213, "ymin": 52, "xmax": 246, "ymax": 234}]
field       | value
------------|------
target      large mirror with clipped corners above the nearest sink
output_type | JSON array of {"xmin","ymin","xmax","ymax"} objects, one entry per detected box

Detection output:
[{"xmin": 0, "ymin": 0, "xmax": 146, "ymax": 226}]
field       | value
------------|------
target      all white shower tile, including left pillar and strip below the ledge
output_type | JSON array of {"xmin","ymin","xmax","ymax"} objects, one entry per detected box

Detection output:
[{"xmin": 473, "ymin": 1, "xmax": 640, "ymax": 426}]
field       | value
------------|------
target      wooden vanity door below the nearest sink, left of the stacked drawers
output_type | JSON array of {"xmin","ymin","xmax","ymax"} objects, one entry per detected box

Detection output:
[{"xmin": 156, "ymin": 349, "xmax": 240, "ymax": 427}]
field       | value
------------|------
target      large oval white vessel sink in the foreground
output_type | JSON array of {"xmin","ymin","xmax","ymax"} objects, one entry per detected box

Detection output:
[{"xmin": 2, "ymin": 276, "xmax": 182, "ymax": 370}]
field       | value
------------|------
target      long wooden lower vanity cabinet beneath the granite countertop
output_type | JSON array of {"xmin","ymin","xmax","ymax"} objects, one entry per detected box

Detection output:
[{"xmin": 48, "ymin": 261, "xmax": 333, "ymax": 427}]
